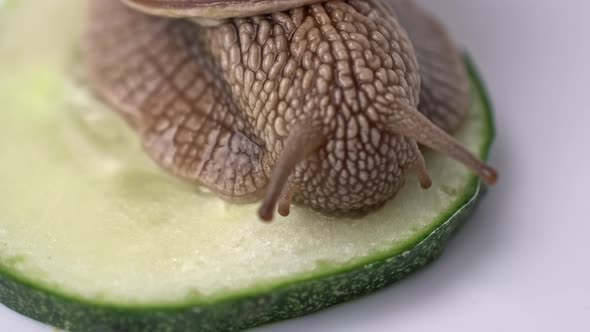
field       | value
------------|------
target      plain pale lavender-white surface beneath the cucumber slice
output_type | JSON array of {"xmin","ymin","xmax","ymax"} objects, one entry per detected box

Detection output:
[{"xmin": 0, "ymin": 0, "xmax": 590, "ymax": 332}]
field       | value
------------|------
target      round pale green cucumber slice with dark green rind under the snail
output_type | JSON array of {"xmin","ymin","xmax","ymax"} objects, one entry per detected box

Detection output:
[{"xmin": 0, "ymin": 0, "xmax": 494, "ymax": 332}]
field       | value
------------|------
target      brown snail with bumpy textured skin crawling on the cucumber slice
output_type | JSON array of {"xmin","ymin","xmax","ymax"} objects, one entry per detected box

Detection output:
[{"xmin": 84, "ymin": 0, "xmax": 497, "ymax": 221}]
